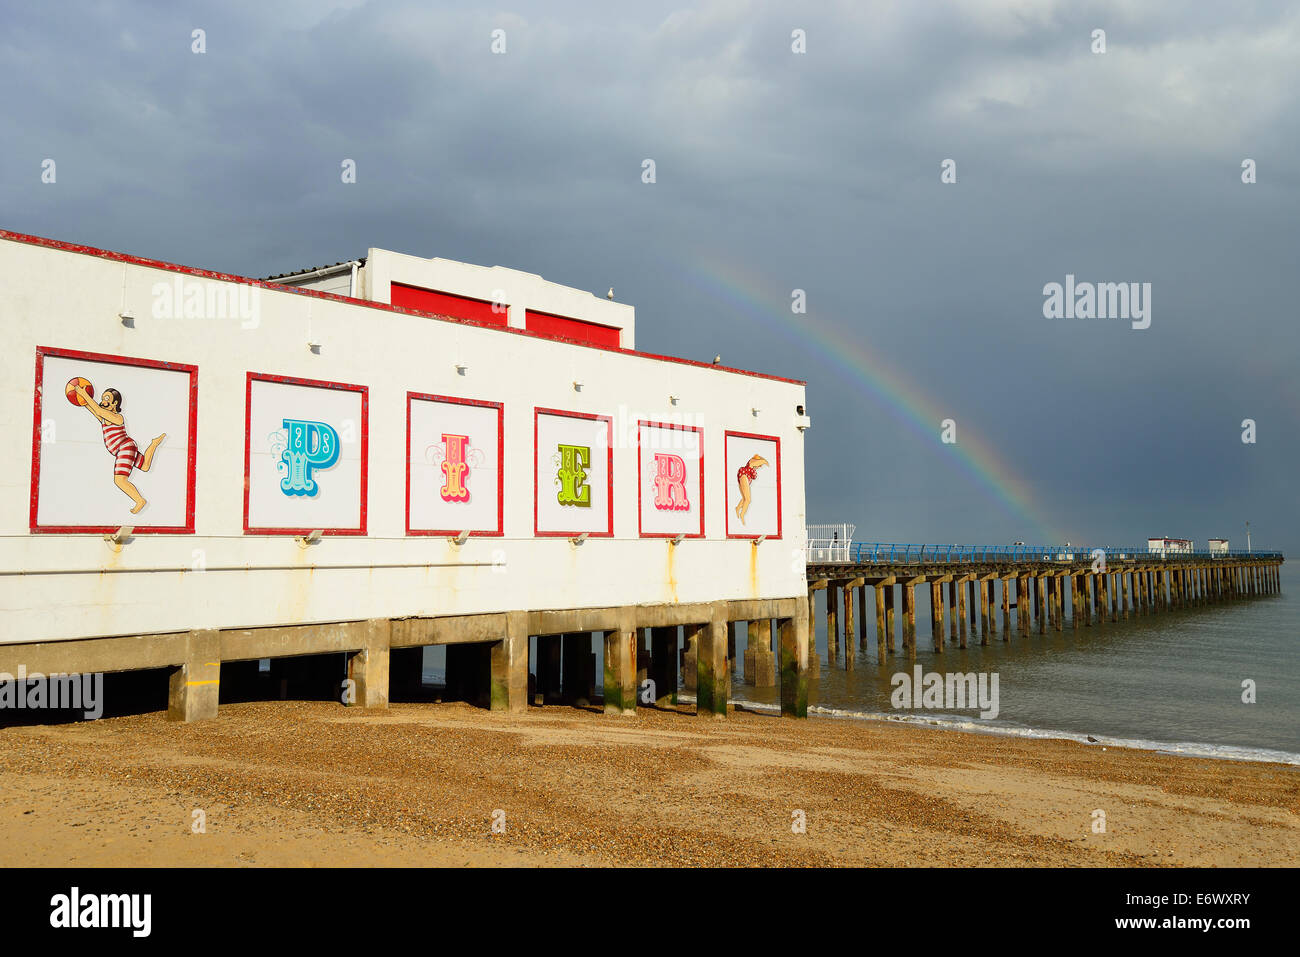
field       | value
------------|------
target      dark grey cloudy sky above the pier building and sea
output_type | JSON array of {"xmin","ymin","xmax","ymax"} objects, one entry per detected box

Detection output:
[{"xmin": 0, "ymin": 0, "xmax": 1300, "ymax": 553}]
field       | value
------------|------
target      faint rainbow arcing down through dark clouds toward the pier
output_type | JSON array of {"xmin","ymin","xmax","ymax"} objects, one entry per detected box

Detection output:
[{"xmin": 664, "ymin": 256, "xmax": 1065, "ymax": 542}]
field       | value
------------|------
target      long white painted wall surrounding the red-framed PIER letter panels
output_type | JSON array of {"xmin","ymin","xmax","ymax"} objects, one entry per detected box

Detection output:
[{"xmin": 0, "ymin": 239, "xmax": 806, "ymax": 644}]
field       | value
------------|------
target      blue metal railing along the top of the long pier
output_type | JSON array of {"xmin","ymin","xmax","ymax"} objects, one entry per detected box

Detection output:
[{"xmin": 809, "ymin": 540, "xmax": 1283, "ymax": 564}]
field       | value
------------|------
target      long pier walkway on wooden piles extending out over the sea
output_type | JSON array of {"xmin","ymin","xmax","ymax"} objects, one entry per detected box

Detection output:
[{"xmin": 807, "ymin": 525, "xmax": 1284, "ymax": 671}]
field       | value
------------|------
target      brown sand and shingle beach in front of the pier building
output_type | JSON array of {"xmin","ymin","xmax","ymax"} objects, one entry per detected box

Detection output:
[{"xmin": 0, "ymin": 701, "xmax": 1300, "ymax": 866}]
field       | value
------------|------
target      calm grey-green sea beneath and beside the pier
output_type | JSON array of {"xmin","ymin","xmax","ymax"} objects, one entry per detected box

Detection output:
[{"xmin": 424, "ymin": 562, "xmax": 1300, "ymax": 765}]
